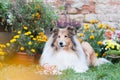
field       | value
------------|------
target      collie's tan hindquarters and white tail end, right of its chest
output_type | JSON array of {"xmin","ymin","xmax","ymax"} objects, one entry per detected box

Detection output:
[{"xmin": 81, "ymin": 42, "xmax": 110, "ymax": 66}]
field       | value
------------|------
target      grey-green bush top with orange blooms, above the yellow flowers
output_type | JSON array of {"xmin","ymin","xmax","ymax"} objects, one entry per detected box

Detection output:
[{"xmin": 11, "ymin": 0, "xmax": 57, "ymax": 33}]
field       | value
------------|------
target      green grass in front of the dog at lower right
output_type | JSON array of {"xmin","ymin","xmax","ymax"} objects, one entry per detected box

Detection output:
[{"xmin": 56, "ymin": 63, "xmax": 120, "ymax": 80}]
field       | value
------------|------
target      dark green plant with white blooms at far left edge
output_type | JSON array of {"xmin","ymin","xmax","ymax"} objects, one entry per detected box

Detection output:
[{"xmin": 0, "ymin": 0, "xmax": 14, "ymax": 32}]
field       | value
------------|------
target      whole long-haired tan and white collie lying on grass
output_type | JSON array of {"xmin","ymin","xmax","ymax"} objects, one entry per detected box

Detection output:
[{"xmin": 40, "ymin": 27, "xmax": 108, "ymax": 73}]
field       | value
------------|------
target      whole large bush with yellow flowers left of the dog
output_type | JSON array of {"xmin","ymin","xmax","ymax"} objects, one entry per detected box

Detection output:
[{"xmin": 1, "ymin": 0, "xmax": 57, "ymax": 55}]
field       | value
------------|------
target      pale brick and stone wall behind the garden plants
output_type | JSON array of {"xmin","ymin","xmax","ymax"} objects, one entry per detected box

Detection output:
[{"xmin": 44, "ymin": 0, "xmax": 120, "ymax": 29}]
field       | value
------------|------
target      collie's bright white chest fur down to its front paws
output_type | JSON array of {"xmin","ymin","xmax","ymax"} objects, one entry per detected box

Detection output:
[{"xmin": 41, "ymin": 47, "xmax": 88, "ymax": 72}]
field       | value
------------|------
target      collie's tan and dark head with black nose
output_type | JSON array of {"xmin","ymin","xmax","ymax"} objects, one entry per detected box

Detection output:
[{"xmin": 51, "ymin": 27, "xmax": 76, "ymax": 50}]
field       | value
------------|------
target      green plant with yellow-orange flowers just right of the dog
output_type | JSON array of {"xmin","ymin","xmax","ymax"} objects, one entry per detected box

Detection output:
[{"xmin": 78, "ymin": 20, "xmax": 114, "ymax": 57}]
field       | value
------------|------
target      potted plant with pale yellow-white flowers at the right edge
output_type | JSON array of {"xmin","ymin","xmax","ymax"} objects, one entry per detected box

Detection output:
[{"xmin": 101, "ymin": 40, "xmax": 120, "ymax": 63}]
